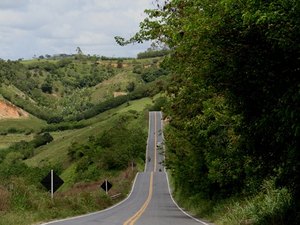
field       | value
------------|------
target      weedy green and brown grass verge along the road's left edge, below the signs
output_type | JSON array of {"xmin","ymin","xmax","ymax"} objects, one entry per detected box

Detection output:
[{"xmin": 0, "ymin": 169, "xmax": 136, "ymax": 225}]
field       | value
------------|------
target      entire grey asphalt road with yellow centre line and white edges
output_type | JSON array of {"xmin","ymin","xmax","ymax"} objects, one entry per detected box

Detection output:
[{"xmin": 44, "ymin": 112, "xmax": 208, "ymax": 225}]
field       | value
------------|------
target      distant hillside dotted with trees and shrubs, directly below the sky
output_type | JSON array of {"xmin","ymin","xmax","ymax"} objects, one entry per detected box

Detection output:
[{"xmin": 0, "ymin": 56, "xmax": 167, "ymax": 123}]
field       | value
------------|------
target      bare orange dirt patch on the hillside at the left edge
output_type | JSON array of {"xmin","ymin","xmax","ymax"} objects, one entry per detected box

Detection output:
[{"xmin": 0, "ymin": 100, "xmax": 29, "ymax": 120}]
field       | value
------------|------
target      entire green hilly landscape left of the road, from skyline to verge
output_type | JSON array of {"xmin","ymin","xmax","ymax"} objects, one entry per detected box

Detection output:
[{"xmin": 0, "ymin": 54, "xmax": 168, "ymax": 225}]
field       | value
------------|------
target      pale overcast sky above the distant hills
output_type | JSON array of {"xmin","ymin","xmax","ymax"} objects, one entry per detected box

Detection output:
[{"xmin": 0, "ymin": 0, "xmax": 153, "ymax": 60}]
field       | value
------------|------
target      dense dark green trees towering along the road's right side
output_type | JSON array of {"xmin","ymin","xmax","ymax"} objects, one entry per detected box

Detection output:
[{"xmin": 116, "ymin": 0, "xmax": 300, "ymax": 224}]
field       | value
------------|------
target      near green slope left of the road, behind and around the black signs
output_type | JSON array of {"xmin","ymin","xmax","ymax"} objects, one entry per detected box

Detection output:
[{"xmin": 0, "ymin": 98, "xmax": 153, "ymax": 225}]
